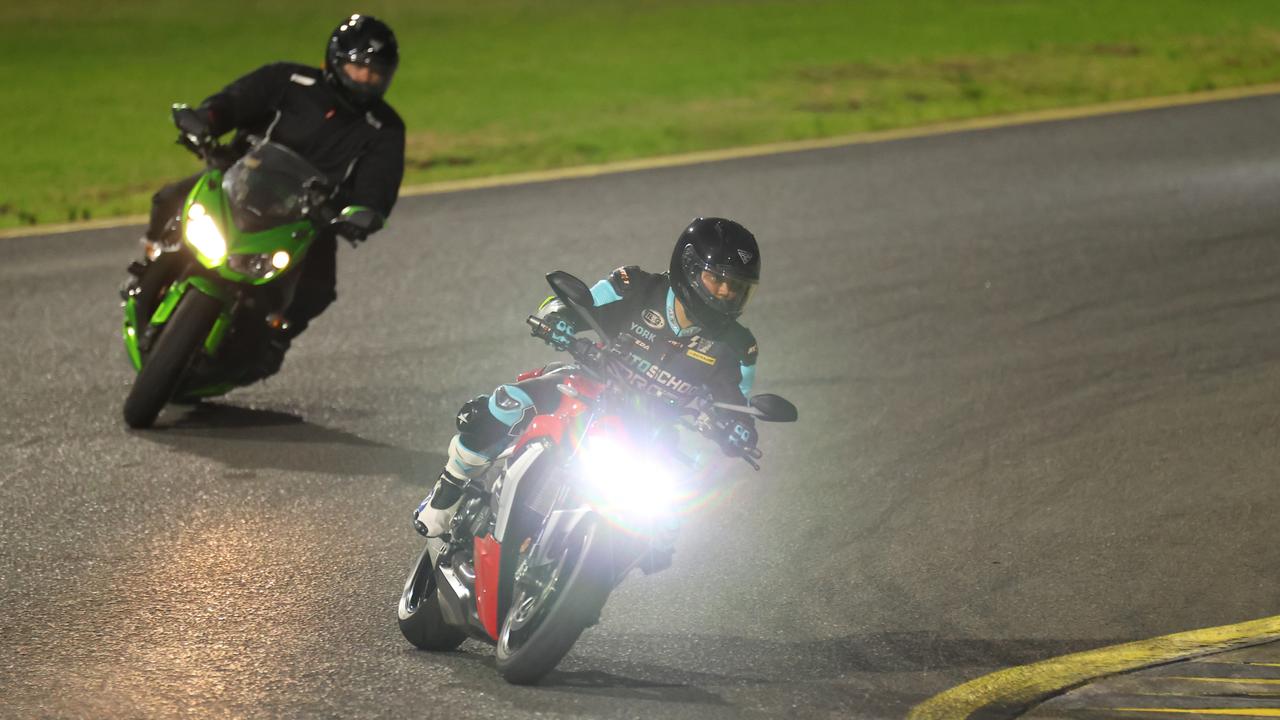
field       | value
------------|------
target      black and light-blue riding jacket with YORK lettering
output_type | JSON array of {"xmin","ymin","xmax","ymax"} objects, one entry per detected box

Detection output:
[{"xmin": 539, "ymin": 266, "xmax": 758, "ymax": 405}]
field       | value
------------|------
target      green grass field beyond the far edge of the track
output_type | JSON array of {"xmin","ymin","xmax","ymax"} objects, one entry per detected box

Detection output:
[{"xmin": 0, "ymin": 0, "xmax": 1280, "ymax": 227}]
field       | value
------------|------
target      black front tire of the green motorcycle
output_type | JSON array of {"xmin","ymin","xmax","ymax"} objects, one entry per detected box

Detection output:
[{"xmin": 124, "ymin": 288, "xmax": 223, "ymax": 428}]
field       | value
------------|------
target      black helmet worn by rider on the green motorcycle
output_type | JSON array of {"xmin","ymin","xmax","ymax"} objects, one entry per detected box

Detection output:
[{"xmin": 324, "ymin": 15, "xmax": 399, "ymax": 108}]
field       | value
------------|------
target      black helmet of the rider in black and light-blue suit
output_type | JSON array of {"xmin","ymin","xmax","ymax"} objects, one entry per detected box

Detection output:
[{"xmin": 671, "ymin": 218, "xmax": 760, "ymax": 328}]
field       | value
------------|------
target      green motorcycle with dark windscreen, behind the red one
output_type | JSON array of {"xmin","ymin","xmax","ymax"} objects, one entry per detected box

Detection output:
[{"xmin": 122, "ymin": 105, "xmax": 380, "ymax": 428}]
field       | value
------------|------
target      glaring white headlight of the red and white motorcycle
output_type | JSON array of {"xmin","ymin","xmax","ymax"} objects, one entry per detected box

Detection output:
[{"xmin": 581, "ymin": 436, "xmax": 682, "ymax": 518}]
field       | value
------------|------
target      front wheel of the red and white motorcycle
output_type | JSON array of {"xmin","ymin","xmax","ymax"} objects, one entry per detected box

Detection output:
[{"xmin": 497, "ymin": 512, "xmax": 613, "ymax": 685}]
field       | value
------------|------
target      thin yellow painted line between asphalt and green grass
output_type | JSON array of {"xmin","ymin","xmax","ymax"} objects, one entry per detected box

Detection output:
[{"xmin": 0, "ymin": 83, "xmax": 1280, "ymax": 240}]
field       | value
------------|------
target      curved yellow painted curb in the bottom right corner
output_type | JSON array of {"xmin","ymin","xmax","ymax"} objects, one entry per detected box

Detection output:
[{"xmin": 908, "ymin": 615, "xmax": 1280, "ymax": 720}]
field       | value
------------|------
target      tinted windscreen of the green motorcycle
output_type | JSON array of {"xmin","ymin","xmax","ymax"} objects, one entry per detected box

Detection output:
[{"xmin": 223, "ymin": 142, "xmax": 324, "ymax": 232}]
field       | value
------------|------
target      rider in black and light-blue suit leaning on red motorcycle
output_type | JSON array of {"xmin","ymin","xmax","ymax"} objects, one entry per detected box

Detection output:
[{"xmin": 413, "ymin": 218, "xmax": 760, "ymax": 545}]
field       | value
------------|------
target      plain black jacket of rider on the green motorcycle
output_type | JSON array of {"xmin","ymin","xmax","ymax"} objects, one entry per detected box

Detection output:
[{"xmin": 201, "ymin": 63, "xmax": 404, "ymax": 218}]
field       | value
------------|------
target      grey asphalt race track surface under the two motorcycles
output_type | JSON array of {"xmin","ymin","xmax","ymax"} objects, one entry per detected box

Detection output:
[{"xmin": 0, "ymin": 97, "xmax": 1280, "ymax": 720}]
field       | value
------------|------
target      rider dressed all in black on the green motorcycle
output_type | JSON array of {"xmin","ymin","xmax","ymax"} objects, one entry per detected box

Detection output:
[{"xmin": 143, "ymin": 14, "xmax": 404, "ymax": 377}]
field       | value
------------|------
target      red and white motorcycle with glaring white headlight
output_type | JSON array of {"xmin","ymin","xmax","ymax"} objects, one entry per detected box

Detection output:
[{"xmin": 398, "ymin": 272, "xmax": 797, "ymax": 684}]
